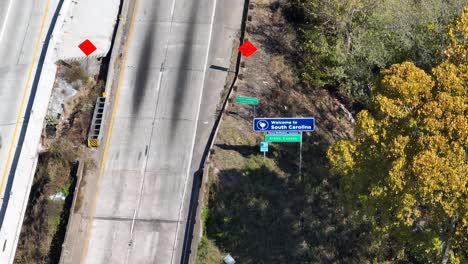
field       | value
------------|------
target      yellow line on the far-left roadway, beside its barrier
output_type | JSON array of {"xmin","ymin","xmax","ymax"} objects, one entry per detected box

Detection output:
[{"xmin": 0, "ymin": 0, "xmax": 50, "ymax": 194}]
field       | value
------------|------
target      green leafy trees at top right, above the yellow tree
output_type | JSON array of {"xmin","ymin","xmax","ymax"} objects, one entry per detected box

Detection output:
[{"xmin": 287, "ymin": 0, "xmax": 466, "ymax": 104}]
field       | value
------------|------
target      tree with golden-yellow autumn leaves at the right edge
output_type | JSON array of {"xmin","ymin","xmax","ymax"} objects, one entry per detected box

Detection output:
[{"xmin": 328, "ymin": 8, "xmax": 468, "ymax": 264}]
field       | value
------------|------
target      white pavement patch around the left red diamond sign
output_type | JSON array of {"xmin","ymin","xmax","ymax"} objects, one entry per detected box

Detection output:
[{"xmin": 56, "ymin": 0, "xmax": 120, "ymax": 60}]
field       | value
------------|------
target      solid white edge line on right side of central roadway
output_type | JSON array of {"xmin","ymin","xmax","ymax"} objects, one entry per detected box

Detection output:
[{"xmin": 171, "ymin": 0, "xmax": 218, "ymax": 263}]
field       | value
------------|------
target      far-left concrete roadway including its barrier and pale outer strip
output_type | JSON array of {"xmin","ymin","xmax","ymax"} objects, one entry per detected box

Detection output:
[{"xmin": 0, "ymin": 0, "xmax": 57, "ymax": 263}]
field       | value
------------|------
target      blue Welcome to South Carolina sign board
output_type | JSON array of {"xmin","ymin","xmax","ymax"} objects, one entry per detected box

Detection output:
[{"xmin": 253, "ymin": 117, "xmax": 315, "ymax": 132}]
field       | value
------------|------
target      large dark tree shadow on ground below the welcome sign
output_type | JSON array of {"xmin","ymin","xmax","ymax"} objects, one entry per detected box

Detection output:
[{"xmin": 206, "ymin": 156, "xmax": 370, "ymax": 263}]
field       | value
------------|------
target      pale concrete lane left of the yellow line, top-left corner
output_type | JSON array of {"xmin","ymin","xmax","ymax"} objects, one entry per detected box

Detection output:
[{"xmin": 0, "ymin": 0, "xmax": 48, "ymax": 207}]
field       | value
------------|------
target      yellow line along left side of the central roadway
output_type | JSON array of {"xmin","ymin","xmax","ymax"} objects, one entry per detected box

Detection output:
[{"xmin": 80, "ymin": 0, "xmax": 139, "ymax": 264}]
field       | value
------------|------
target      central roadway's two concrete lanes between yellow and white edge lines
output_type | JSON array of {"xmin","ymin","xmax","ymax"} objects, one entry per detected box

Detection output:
[{"xmin": 81, "ymin": 0, "xmax": 216, "ymax": 264}]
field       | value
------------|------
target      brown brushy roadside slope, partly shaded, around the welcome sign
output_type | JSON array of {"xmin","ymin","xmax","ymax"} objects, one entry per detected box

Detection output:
[{"xmin": 197, "ymin": 1, "xmax": 362, "ymax": 264}]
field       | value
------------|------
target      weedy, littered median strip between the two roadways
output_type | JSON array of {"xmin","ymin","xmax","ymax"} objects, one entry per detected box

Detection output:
[{"xmin": 15, "ymin": 62, "xmax": 101, "ymax": 264}]
